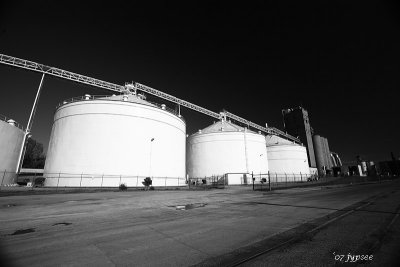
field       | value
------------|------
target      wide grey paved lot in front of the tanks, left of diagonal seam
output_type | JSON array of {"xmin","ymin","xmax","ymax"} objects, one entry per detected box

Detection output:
[{"xmin": 0, "ymin": 181, "xmax": 398, "ymax": 266}]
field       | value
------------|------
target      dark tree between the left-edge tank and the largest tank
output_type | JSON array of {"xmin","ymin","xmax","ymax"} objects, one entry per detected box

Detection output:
[{"xmin": 22, "ymin": 138, "xmax": 46, "ymax": 169}]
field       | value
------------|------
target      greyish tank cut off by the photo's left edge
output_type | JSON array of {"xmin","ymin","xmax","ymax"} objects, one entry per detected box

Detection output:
[{"xmin": 0, "ymin": 116, "xmax": 24, "ymax": 185}]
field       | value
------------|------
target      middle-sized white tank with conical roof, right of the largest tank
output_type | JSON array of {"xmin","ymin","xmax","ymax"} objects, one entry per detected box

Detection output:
[{"xmin": 187, "ymin": 120, "xmax": 268, "ymax": 184}]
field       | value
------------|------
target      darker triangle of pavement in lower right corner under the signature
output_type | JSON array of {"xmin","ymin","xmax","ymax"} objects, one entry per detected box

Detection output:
[{"xmin": 241, "ymin": 181, "xmax": 400, "ymax": 266}]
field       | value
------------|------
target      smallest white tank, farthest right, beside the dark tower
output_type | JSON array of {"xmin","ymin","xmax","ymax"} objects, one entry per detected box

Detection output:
[{"xmin": 266, "ymin": 135, "xmax": 310, "ymax": 182}]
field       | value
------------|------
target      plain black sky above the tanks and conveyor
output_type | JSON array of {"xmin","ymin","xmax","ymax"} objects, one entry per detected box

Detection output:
[{"xmin": 0, "ymin": 1, "xmax": 400, "ymax": 161}]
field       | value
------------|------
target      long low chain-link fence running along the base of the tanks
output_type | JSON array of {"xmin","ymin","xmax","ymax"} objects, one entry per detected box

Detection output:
[{"xmin": 0, "ymin": 170, "xmax": 399, "ymax": 193}]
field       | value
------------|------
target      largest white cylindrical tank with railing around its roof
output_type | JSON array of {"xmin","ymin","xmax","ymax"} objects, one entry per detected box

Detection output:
[{"xmin": 44, "ymin": 95, "xmax": 186, "ymax": 187}]
